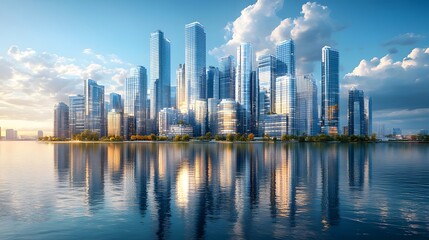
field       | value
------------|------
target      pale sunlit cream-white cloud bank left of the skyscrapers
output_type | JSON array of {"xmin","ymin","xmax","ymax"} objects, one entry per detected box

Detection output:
[{"xmin": 0, "ymin": 46, "xmax": 130, "ymax": 130}]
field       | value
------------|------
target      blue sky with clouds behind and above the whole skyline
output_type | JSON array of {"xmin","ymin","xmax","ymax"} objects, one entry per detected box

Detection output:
[{"xmin": 0, "ymin": 0, "xmax": 429, "ymax": 136}]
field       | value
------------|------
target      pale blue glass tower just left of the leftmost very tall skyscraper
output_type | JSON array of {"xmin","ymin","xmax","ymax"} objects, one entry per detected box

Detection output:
[{"xmin": 124, "ymin": 66, "xmax": 147, "ymax": 138}]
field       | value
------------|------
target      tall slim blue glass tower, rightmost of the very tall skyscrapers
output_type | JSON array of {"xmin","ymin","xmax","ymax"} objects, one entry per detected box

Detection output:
[{"xmin": 320, "ymin": 46, "xmax": 340, "ymax": 135}]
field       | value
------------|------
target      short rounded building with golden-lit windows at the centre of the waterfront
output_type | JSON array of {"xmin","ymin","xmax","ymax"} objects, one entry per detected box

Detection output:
[{"xmin": 218, "ymin": 98, "xmax": 238, "ymax": 135}]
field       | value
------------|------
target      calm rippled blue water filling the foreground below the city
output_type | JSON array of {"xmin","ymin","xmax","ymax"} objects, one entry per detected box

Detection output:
[{"xmin": 0, "ymin": 142, "xmax": 429, "ymax": 239}]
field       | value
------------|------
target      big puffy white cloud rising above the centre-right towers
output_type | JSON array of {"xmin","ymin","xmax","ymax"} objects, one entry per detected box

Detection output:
[{"xmin": 210, "ymin": 0, "xmax": 341, "ymax": 74}]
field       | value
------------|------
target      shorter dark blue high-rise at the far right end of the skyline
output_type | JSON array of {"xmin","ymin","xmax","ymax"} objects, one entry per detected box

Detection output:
[{"xmin": 347, "ymin": 88, "xmax": 372, "ymax": 136}]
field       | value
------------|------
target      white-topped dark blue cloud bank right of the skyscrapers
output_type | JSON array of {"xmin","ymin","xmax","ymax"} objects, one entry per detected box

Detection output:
[{"xmin": 341, "ymin": 48, "xmax": 429, "ymax": 131}]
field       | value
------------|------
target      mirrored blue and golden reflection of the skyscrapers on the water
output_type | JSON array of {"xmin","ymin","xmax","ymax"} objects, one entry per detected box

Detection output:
[{"xmin": 48, "ymin": 143, "xmax": 428, "ymax": 239}]
